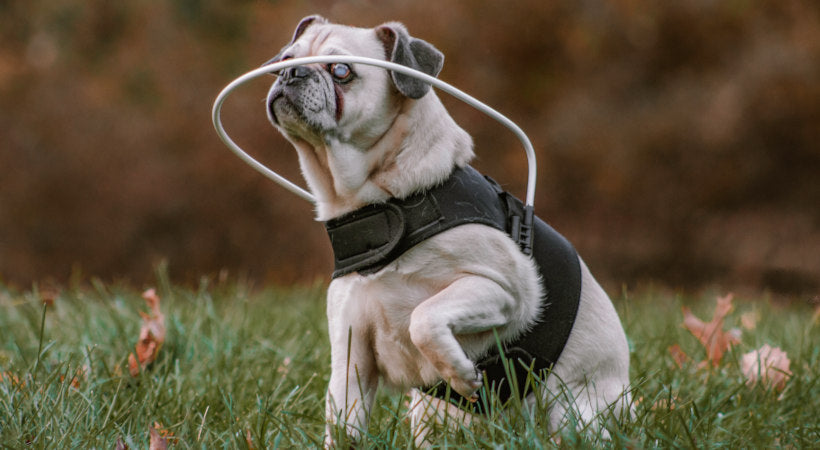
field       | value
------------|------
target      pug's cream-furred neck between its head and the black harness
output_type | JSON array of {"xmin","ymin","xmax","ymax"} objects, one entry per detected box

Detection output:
[{"xmin": 291, "ymin": 91, "xmax": 474, "ymax": 221}]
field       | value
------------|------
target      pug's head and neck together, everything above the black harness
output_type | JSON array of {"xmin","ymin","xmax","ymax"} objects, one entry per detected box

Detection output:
[{"xmin": 266, "ymin": 16, "xmax": 472, "ymax": 219}]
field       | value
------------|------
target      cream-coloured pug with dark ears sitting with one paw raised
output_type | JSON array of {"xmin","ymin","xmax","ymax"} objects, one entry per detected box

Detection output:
[{"xmin": 267, "ymin": 16, "xmax": 629, "ymax": 445}]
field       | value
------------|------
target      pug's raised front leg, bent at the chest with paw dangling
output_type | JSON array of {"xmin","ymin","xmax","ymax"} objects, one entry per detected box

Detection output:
[{"xmin": 410, "ymin": 275, "xmax": 516, "ymax": 401}]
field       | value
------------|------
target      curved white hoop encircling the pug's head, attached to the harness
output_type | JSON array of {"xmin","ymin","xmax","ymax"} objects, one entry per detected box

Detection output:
[{"xmin": 212, "ymin": 55, "xmax": 536, "ymax": 207}]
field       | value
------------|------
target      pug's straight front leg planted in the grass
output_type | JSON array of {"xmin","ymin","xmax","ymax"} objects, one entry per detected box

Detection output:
[{"xmin": 325, "ymin": 298, "xmax": 378, "ymax": 447}]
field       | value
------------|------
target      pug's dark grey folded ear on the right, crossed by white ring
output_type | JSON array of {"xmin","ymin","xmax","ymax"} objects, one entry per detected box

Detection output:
[{"xmin": 376, "ymin": 22, "xmax": 444, "ymax": 99}]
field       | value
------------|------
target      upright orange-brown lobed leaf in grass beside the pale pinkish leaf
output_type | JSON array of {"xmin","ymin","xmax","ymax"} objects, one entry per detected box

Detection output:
[{"xmin": 683, "ymin": 294, "xmax": 740, "ymax": 367}]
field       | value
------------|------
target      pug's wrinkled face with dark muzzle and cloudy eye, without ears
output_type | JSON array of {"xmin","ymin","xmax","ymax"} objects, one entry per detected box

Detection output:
[{"xmin": 266, "ymin": 23, "xmax": 400, "ymax": 148}]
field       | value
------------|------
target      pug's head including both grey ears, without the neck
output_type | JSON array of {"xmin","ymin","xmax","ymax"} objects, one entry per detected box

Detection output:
[{"xmin": 267, "ymin": 16, "xmax": 444, "ymax": 138}]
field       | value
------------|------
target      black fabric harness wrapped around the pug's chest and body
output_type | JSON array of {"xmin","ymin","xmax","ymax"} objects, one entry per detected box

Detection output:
[{"xmin": 325, "ymin": 166, "xmax": 581, "ymax": 412}]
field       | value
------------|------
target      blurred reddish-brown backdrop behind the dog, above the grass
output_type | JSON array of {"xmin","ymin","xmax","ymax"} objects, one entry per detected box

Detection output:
[{"xmin": 0, "ymin": 0, "xmax": 820, "ymax": 296}]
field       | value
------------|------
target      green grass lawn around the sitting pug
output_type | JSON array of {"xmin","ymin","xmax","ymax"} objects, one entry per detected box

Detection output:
[{"xmin": 0, "ymin": 275, "xmax": 820, "ymax": 448}]
